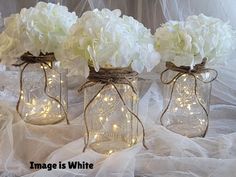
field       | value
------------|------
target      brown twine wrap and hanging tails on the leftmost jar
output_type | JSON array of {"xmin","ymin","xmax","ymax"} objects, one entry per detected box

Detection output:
[{"xmin": 13, "ymin": 52, "xmax": 69, "ymax": 124}]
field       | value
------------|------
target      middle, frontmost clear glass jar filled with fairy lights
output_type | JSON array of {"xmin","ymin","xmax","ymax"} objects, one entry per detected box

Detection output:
[{"xmin": 84, "ymin": 69, "xmax": 141, "ymax": 154}]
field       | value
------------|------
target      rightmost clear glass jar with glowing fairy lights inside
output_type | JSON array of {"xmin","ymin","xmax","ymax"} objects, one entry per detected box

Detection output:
[{"xmin": 161, "ymin": 70, "xmax": 212, "ymax": 138}]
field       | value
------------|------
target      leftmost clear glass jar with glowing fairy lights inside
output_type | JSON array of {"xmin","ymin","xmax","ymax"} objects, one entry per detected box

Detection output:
[{"xmin": 18, "ymin": 53, "xmax": 67, "ymax": 125}]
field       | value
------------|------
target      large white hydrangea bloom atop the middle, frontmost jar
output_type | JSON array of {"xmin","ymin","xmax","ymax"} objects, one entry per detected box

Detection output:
[{"xmin": 59, "ymin": 9, "xmax": 160, "ymax": 73}]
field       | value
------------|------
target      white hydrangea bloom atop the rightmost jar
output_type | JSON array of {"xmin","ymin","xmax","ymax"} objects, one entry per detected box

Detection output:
[{"xmin": 155, "ymin": 14, "xmax": 235, "ymax": 66}]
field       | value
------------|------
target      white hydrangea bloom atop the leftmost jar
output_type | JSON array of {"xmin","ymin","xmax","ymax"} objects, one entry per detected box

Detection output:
[{"xmin": 0, "ymin": 2, "xmax": 78, "ymax": 64}]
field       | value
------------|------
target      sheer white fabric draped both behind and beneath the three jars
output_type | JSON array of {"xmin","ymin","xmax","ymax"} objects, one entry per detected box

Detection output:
[{"xmin": 0, "ymin": 0, "xmax": 236, "ymax": 177}]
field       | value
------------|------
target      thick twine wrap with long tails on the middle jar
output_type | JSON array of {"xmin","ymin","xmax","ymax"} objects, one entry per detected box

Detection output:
[{"xmin": 78, "ymin": 67, "xmax": 148, "ymax": 152}]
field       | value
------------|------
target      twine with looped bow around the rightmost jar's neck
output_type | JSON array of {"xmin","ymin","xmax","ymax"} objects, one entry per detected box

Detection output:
[{"xmin": 160, "ymin": 58, "xmax": 218, "ymax": 136}]
